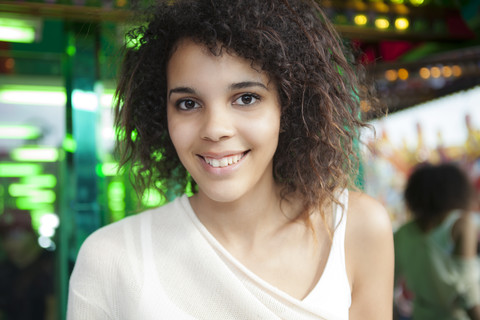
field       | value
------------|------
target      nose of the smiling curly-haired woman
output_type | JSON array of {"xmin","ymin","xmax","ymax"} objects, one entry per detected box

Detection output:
[{"xmin": 200, "ymin": 105, "xmax": 235, "ymax": 141}]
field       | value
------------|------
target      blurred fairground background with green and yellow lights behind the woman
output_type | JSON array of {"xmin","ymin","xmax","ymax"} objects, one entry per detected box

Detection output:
[{"xmin": 0, "ymin": 0, "xmax": 480, "ymax": 320}]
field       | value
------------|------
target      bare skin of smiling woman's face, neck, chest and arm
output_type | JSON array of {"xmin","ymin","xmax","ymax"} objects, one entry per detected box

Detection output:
[{"xmin": 167, "ymin": 39, "xmax": 393, "ymax": 320}]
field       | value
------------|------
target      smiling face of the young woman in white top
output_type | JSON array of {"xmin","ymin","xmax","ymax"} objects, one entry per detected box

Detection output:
[{"xmin": 167, "ymin": 40, "xmax": 280, "ymax": 202}]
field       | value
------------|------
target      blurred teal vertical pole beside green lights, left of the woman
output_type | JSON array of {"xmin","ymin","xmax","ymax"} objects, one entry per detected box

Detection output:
[{"xmin": 58, "ymin": 21, "xmax": 102, "ymax": 319}]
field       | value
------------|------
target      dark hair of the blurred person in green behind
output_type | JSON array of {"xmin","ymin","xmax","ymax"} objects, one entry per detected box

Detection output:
[{"xmin": 404, "ymin": 163, "xmax": 474, "ymax": 231}]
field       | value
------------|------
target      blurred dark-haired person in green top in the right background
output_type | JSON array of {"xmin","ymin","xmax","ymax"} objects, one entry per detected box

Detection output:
[{"xmin": 394, "ymin": 163, "xmax": 480, "ymax": 320}]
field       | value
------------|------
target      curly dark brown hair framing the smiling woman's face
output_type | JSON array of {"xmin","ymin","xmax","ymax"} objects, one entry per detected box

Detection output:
[{"xmin": 115, "ymin": 0, "xmax": 372, "ymax": 219}]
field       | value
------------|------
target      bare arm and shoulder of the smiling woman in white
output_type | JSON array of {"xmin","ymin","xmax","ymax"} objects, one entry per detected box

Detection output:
[{"xmin": 345, "ymin": 192, "xmax": 394, "ymax": 320}]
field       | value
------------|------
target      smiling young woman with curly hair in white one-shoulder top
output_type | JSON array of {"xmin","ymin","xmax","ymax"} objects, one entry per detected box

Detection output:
[{"xmin": 68, "ymin": 0, "xmax": 393, "ymax": 320}]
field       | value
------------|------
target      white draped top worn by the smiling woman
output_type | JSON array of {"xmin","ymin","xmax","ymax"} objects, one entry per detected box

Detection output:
[{"xmin": 67, "ymin": 192, "xmax": 351, "ymax": 320}]
